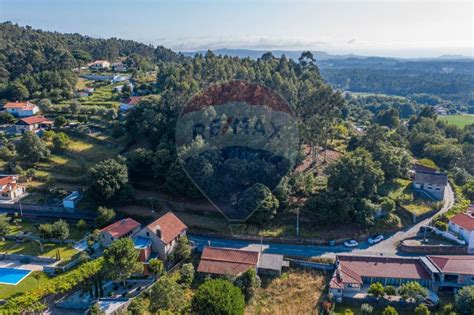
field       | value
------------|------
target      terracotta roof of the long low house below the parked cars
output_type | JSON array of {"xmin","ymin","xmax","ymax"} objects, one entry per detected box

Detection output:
[{"xmin": 337, "ymin": 255, "xmax": 431, "ymax": 283}]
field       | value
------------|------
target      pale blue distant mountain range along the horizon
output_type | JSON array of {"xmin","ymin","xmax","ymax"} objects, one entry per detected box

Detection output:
[{"xmin": 182, "ymin": 48, "xmax": 473, "ymax": 61}]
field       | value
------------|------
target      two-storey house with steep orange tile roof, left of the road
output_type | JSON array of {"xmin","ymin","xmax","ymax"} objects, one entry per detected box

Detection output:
[{"xmin": 135, "ymin": 212, "xmax": 188, "ymax": 261}]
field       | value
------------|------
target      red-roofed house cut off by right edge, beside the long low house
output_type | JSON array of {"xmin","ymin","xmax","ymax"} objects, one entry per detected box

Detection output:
[{"xmin": 422, "ymin": 255, "xmax": 474, "ymax": 290}]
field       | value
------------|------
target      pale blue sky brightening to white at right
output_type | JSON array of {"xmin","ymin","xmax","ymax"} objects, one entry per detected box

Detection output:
[{"xmin": 0, "ymin": 0, "xmax": 474, "ymax": 57}]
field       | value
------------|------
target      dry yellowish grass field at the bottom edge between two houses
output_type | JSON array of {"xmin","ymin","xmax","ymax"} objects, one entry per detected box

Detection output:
[{"xmin": 245, "ymin": 271, "xmax": 325, "ymax": 315}]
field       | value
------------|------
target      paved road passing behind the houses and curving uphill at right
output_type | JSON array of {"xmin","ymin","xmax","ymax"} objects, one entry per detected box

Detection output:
[{"xmin": 189, "ymin": 186, "xmax": 454, "ymax": 257}]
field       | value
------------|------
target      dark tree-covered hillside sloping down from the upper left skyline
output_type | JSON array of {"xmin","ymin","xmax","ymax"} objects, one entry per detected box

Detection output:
[{"xmin": 0, "ymin": 22, "xmax": 177, "ymax": 100}]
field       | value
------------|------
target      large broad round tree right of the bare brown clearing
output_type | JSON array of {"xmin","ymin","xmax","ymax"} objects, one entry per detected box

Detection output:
[{"xmin": 327, "ymin": 148, "xmax": 384, "ymax": 198}]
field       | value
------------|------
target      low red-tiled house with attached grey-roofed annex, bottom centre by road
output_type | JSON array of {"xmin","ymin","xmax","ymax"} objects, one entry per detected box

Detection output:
[{"xmin": 197, "ymin": 246, "xmax": 289, "ymax": 277}]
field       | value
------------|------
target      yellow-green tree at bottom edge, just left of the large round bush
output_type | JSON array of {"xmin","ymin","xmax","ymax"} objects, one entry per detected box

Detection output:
[{"xmin": 150, "ymin": 276, "xmax": 184, "ymax": 313}]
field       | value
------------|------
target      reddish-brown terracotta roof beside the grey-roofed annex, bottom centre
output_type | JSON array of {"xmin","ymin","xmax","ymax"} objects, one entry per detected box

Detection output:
[{"xmin": 197, "ymin": 246, "xmax": 259, "ymax": 276}]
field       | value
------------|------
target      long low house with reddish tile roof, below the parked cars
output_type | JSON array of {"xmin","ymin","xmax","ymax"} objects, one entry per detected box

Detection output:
[{"xmin": 329, "ymin": 255, "xmax": 433, "ymax": 299}]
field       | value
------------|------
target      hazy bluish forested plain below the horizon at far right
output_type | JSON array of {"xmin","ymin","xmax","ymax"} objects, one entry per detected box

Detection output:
[{"xmin": 318, "ymin": 58, "xmax": 474, "ymax": 112}]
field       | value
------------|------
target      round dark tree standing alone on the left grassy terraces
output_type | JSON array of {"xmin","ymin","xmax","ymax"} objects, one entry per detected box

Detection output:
[{"xmin": 89, "ymin": 157, "xmax": 128, "ymax": 200}]
